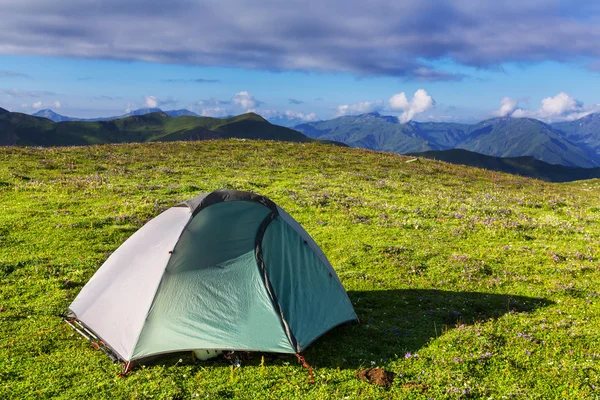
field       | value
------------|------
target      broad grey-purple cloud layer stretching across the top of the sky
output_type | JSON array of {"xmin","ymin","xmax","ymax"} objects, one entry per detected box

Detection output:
[{"xmin": 0, "ymin": 0, "xmax": 600, "ymax": 77}]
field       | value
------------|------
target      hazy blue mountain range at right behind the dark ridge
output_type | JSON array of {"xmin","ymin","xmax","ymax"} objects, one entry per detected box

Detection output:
[{"xmin": 294, "ymin": 113, "xmax": 600, "ymax": 168}]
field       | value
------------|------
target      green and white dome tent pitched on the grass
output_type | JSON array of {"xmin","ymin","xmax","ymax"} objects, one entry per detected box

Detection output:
[{"xmin": 69, "ymin": 190, "xmax": 357, "ymax": 362}]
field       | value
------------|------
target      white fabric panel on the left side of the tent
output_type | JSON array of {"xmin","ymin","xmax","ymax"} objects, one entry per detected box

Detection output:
[{"xmin": 69, "ymin": 207, "xmax": 191, "ymax": 360}]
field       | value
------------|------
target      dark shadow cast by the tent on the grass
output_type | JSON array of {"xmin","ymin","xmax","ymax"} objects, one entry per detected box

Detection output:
[{"xmin": 305, "ymin": 289, "xmax": 554, "ymax": 369}]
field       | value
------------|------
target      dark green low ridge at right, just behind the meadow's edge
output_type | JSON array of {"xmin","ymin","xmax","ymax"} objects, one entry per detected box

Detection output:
[{"xmin": 409, "ymin": 149, "xmax": 600, "ymax": 182}]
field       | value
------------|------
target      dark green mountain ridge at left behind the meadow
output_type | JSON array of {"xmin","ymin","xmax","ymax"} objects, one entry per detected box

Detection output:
[{"xmin": 0, "ymin": 112, "xmax": 345, "ymax": 146}]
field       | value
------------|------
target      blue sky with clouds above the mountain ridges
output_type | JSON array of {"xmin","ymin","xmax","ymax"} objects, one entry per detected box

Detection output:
[{"xmin": 0, "ymin": 0, "xmax": 600, "ymax": 123}]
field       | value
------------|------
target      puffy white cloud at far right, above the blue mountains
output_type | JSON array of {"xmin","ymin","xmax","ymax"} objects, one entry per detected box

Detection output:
[{"xmin": 511, "ymin": 92, "xmax": 600, "ymax": 122}]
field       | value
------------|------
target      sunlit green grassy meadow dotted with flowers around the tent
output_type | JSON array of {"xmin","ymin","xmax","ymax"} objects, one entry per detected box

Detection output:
[{"xmin": 0, "ymin": 140, "xmax": 600, "ymax": 399}]
